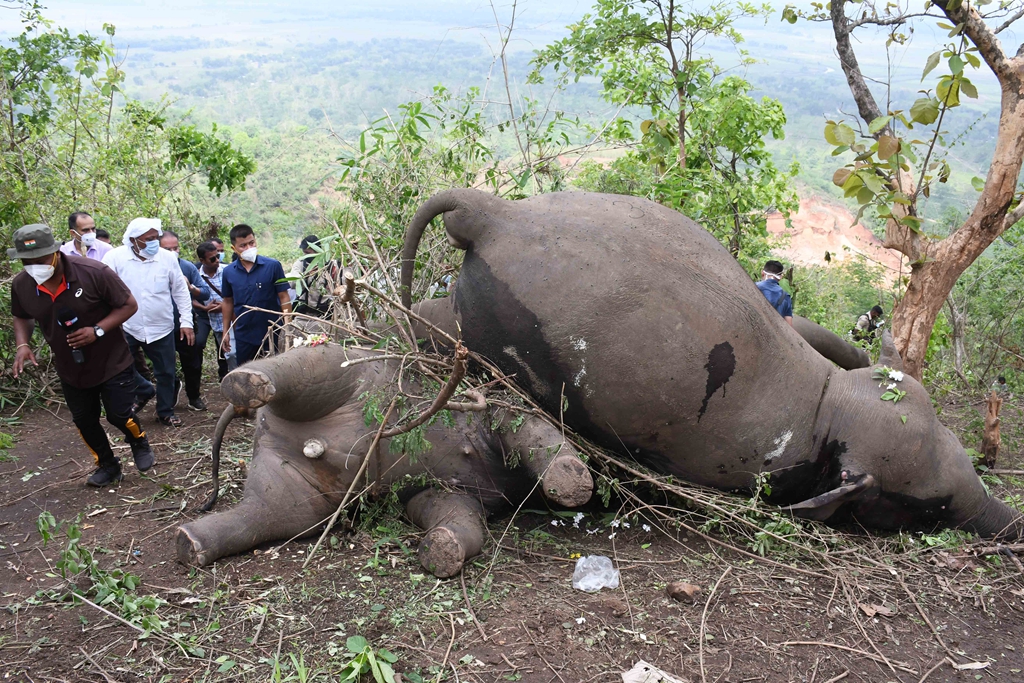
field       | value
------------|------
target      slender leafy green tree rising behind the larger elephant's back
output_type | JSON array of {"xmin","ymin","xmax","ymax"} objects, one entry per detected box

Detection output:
[{"xmin": 530, "ymin": 0, "xmax": 796, "ymax": 267}]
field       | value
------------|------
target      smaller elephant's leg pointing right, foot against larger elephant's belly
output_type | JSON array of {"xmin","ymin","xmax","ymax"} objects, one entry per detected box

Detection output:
[{"xmin": 501, "ymin": 417, "xmax": 594, "ymax": 508}]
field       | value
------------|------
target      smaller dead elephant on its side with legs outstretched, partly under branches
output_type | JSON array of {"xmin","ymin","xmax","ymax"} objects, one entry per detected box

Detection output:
[{"xmin": 176, "ymin": 344, "xmax": 594, "ymax": 577}]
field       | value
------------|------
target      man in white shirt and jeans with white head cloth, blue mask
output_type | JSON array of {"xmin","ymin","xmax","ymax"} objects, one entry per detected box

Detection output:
[{"xmin": 103, "ymin": 218, "xmax": 196, "ymax": 427}]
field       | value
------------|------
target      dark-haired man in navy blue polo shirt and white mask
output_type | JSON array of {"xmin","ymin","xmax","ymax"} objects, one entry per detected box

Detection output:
[{"xmin": 220, "ymin": 224, "xmax": 292, "ymax": 366}]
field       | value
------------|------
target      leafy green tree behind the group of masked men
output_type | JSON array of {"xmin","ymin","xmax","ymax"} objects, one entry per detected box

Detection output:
[{"xmin": 0, "ymin": 4, "xmax": 255, "ymax": 241}]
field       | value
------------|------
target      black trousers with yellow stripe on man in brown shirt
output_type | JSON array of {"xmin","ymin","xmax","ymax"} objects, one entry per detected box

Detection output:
[{"xmin": 60, "ymin": 367, "xmax": 145, "ymax": 467}]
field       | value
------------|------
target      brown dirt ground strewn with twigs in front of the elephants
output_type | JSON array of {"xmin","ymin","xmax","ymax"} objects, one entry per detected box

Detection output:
[{"xmin": 0, "ymin": 387, "xmax": 1024, "ymax": 683}]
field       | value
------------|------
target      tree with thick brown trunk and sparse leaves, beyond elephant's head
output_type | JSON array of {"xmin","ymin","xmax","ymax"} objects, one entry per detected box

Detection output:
[{"xmin": 783, "ymin": 0, "xmax": 1024, "ymax": 379}]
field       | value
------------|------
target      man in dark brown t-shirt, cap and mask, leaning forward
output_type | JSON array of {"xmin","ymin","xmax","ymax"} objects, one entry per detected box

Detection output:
[{"xmin": 7, "ymin": 224, "xmax": 154, "ymax": 486}]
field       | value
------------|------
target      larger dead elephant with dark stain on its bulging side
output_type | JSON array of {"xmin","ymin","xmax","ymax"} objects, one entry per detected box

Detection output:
[{"xmin": 401, "ymin": 189, "xmax": 1024, "ymax": 538}]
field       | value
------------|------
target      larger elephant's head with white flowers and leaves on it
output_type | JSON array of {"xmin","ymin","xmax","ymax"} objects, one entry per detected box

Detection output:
[{"xmin": 780, "ymin": 332, "xmax": 1024, "ymax": 539}]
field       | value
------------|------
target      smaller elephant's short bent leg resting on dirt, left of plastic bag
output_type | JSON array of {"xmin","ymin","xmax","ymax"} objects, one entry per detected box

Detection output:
[{"xmin": 406, "ymin": 488, "xmax": 486, "ymax": 579}]
